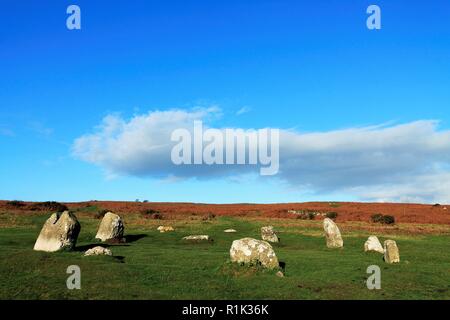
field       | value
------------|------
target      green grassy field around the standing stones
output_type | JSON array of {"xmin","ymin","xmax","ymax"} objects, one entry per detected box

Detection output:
[{"xmin": 0, "ymin": 212, "xmax": 450, "ymax": 299}]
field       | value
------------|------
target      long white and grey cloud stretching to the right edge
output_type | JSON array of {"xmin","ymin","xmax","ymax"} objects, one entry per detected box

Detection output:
[{"xmin": 73, "ymin": 107, "xmax": 450, "ymax": 202}]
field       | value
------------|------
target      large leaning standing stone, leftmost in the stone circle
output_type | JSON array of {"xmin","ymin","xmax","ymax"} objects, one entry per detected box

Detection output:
[{"xmin": 34, "ymin": 211, "xmax": 81, "ymax": 252}]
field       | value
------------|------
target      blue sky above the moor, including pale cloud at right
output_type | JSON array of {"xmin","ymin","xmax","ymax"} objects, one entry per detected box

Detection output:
[{"xmin": 0, "ymin": 0, "xmax": 450, "ymax": 202}]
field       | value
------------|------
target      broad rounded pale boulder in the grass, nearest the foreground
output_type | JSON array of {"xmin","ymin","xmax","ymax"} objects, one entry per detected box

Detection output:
[{"xmin": 230, "ymin": 238, "xmax": 279, "ymax": 269}]
